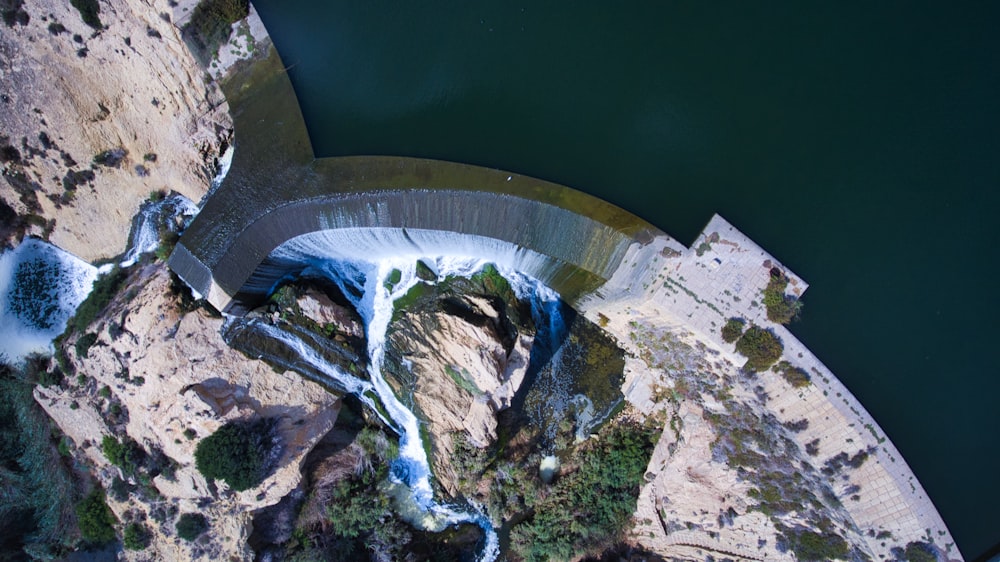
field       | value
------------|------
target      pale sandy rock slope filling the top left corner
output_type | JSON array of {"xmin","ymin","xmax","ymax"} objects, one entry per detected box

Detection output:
[{"xmin": 0, "ymin": 0, "xmax": 232, "ymax": 261}]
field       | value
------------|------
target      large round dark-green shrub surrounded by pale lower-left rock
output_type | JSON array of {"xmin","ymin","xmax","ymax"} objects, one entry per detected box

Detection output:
[{"xmin": 194, "ymin": 419, "xmax": 274, "ymax": 491}]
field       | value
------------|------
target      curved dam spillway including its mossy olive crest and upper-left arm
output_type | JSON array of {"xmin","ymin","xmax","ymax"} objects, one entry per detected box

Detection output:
[{"xmin": 169, "ymin": 43, "xmax": 662, "ymax": 313}]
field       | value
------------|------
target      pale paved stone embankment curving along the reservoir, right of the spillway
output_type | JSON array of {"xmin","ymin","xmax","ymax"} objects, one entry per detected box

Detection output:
[{"xmin": 580, "ymin": 215, "xmax": 961, "ymax": 560}]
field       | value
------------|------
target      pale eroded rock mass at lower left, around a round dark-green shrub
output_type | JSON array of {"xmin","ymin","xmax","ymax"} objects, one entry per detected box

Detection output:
[{"xmin": 36, "ymin": 264, "xmax": 340, "ymax": 560}]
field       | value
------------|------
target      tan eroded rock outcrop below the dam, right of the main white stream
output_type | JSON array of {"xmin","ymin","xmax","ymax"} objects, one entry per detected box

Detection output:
[{"xmin": 386, "ymin": 281, "xmax": 534, "ymax": 494}]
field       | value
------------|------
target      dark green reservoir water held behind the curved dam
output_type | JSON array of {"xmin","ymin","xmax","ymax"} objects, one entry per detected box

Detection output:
[{"xmin": 255, "ymin": 0, "xmax": 1000, "ymax": 559}]
